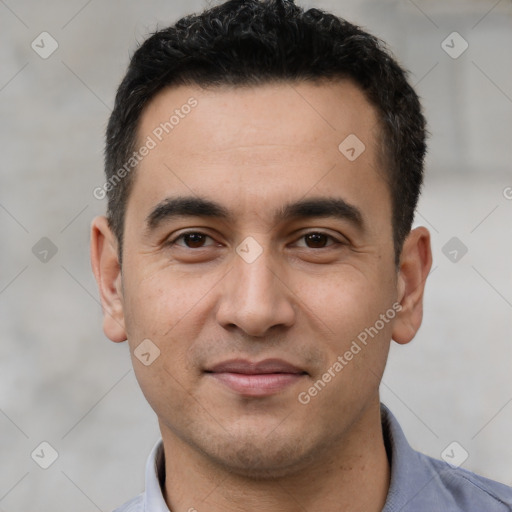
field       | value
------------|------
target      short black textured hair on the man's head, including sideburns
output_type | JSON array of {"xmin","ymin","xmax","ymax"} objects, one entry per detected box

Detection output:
[{"xmin": 105, "ymin": 0, "xmax": 426, "ymax": 263}]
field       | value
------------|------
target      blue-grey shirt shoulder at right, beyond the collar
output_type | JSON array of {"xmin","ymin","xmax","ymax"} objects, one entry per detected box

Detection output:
[{"xmin": 416, "ymin": 452, "xmax": 512, "ymax": 512}]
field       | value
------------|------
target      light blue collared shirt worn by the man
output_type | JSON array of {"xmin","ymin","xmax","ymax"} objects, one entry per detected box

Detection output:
[{"xmin": 114, "ymin": 404, "xmax": 512, "ymax": 512}]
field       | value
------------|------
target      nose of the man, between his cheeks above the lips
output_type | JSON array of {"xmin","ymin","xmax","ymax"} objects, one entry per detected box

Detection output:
[{"xmin": 217, "ymin": 245, "xmax": 297, "ymax": 337}]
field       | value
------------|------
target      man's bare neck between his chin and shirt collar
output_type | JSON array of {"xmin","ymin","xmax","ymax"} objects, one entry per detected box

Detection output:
[{"xmin": 161, "ymin": 403, "xmax": 390, "ymax": 512}]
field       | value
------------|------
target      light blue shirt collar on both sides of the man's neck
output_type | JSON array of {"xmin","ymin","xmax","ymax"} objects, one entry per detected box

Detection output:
[{"xmin": 144, "ymin": 404, "xmax": 439, "ymax": 512}]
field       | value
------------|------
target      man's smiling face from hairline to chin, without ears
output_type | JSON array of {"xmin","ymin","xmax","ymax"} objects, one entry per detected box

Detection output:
[{"xmin": 106, "ymin": 81, "xmax": 406, "ymax": 475}]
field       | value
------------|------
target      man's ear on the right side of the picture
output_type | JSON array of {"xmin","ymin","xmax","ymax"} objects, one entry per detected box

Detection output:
[{"xmin": 392, "ymin": 227, "xmax": 432, "ymax": 344}]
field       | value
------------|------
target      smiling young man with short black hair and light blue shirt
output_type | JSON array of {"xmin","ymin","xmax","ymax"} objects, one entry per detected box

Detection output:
[{"xmin": 91, "ymin": 0, "xmax": 512, "ymax": 512}]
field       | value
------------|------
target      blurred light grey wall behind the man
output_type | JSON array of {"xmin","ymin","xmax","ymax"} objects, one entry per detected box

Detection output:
[{"xmin": 0, "ymin": 0, "xmax": 512, "ymax": 512}]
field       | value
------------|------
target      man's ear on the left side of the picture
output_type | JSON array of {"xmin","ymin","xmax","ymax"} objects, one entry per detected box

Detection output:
[{"xmin": 91, "ymin": 216, "xmax": 126, "ymax": 342}]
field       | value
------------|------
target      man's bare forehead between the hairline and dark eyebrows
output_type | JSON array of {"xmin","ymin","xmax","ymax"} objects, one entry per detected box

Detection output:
[{"xmin": 130, "ymin": 80, "xmax": 389, "ymax": 230}]
